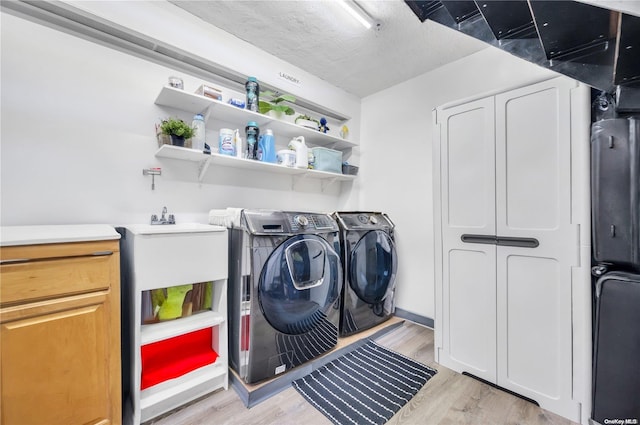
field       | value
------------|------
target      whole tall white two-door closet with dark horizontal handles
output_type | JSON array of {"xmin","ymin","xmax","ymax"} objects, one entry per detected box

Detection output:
[{"xmin": 434, "ymin": 78, "xmax": 590, "ymax": 421}]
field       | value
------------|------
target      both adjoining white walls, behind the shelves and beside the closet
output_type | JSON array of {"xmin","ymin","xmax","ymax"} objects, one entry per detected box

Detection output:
[{"xmin": 0, "ymin": 2, "xmax": 572, "ymax": 317}]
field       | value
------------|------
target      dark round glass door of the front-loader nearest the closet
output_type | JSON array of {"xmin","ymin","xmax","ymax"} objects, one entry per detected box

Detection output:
[{"xmin": 349, "ymin": 230, "xmax": 398, "ymax": 305}]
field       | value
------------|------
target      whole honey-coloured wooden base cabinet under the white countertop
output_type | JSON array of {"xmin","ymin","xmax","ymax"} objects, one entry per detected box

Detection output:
[{"xmin": 0, "ymin": 229, "xmax": 122, "ymax": 425}]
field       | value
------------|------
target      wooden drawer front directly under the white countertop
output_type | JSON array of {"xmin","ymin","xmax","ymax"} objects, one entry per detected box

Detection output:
[{"xmin": 0, "ymin": 255, "xmax": 117, "ymax": 304}]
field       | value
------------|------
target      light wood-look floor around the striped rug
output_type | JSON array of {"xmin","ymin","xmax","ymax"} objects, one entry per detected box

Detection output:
[{"xmin": 150, "ymin": 321, "xmax": 574, "ymax": 425}]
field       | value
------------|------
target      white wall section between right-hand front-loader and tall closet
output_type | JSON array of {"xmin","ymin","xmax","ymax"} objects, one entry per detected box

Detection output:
[{"xmin": 360, "ymin": 47, "xmax": 556, "ymax": 318}]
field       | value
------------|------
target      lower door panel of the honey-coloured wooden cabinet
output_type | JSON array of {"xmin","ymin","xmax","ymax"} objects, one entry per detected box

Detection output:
[{"xmin": 0, "ymin": 291, "xmax": 115, "ymax": 425}]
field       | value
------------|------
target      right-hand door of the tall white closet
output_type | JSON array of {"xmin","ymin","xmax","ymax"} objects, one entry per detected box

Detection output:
[{"xmin": 496, "ymin": 79, "xmax": 579, "ymax": 418}]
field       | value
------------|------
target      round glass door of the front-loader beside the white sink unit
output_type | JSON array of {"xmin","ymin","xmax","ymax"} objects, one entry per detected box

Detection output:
[{"xmin": 258, "ymin": 235, "xmax": 342, "ymax": 335}]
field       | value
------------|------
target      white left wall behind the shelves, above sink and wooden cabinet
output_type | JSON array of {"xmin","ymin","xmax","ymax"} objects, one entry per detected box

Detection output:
[{"xmin": 0, "ymin": 2, "xmax": 360, "ymax": 225}]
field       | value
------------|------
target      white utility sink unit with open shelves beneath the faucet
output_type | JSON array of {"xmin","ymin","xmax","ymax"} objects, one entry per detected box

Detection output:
[{"xmin": 123, "ymin": 223, "xmax": 229, "ymax": 425}]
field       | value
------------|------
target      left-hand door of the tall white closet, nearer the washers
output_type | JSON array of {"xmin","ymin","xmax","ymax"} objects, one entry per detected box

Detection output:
[{"xmin": 438, "ymin": 98, "xmax": 496, "ymax": 381}]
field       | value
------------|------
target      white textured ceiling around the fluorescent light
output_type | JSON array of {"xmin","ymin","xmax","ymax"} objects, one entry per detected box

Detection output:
[{"xmin": 172, "ymin": 0, "xmax": 488, "ymax": 97}]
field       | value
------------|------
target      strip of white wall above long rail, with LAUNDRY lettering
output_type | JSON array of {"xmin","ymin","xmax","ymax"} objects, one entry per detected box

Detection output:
[{"xmin": 65, "ymin": 0, "xmax": 360, "ymax": 129}]
